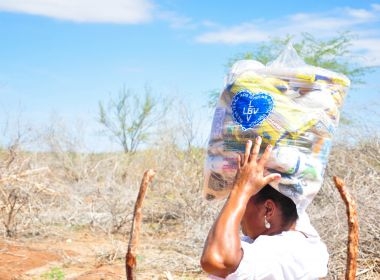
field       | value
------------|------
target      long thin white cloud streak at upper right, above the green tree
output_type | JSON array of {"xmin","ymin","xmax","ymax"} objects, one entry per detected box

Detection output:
[{"xmin": 196, "ymin": 5, "xmax": 380, "ymax": 43}]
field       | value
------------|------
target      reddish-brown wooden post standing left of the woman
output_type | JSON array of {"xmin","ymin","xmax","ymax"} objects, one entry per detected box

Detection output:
[{"xmin": 125, "ymin": 169, "xmax": 156, "ymax": 280}]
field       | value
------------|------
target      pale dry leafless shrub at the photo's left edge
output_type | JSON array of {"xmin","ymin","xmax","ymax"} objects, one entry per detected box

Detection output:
[{"xmin": 0, "ymin": 146, "xmax": 58, "ymax": 237}]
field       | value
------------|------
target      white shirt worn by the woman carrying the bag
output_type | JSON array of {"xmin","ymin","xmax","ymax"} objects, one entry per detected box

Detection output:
[{"xmin": 210, "ymin": 231, "xmax": 329, "ymax": 280}]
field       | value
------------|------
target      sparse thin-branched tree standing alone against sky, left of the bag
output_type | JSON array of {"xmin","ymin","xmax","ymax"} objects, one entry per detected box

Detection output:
[{"xmin": 98, "ymin": 87, "xmax": 167, "ymax": 153}]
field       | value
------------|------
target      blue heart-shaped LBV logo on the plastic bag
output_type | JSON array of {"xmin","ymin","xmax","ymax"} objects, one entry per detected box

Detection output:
[{"xmin": 231, "ymin": 90, "xmax": 273, "ymax": 130}]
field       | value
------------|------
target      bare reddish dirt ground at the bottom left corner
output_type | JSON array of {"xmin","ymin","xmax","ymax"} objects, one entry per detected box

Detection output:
[{"xmin": 0, "ymin": 230, "xmax": 126, "ymax": 280}]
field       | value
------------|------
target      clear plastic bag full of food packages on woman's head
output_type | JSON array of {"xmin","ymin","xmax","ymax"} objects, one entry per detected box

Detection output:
[{"xmin": 203, "ymin": 44, "xmax": 350, "ymax": 213}]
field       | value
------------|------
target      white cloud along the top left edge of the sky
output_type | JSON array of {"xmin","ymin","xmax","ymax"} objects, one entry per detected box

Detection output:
[{"xmin": 0, "ymin": 0, "xmax": 154, "ymax": 24}]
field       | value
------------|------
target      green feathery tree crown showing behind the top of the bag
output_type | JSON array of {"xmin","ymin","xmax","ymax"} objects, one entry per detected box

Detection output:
[{"xmin": 208, "ymin": 32, "xmax": 373, "ymax": 107}]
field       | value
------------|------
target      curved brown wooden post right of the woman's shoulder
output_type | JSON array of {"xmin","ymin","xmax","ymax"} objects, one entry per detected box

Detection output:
[{"xmin": 334, "ymin": 176, "xmax": 359, "ymax": 280}]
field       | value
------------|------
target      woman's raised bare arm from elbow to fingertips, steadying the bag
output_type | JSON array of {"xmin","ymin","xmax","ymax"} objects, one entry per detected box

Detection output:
[{"xmin": 201, "ymin": 137, "xmax": 280, "ymax": 277}]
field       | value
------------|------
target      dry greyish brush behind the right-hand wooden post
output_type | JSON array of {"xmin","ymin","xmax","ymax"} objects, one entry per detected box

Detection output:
[{"xmin": 309, "ymin": 137, "xmax": 380, "ymax": 279}]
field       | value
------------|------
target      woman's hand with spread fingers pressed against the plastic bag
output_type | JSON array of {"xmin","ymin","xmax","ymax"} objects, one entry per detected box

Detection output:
[{"xmin": 234, "ymin": 136, "xmax": 281, "ymax": 197}]
